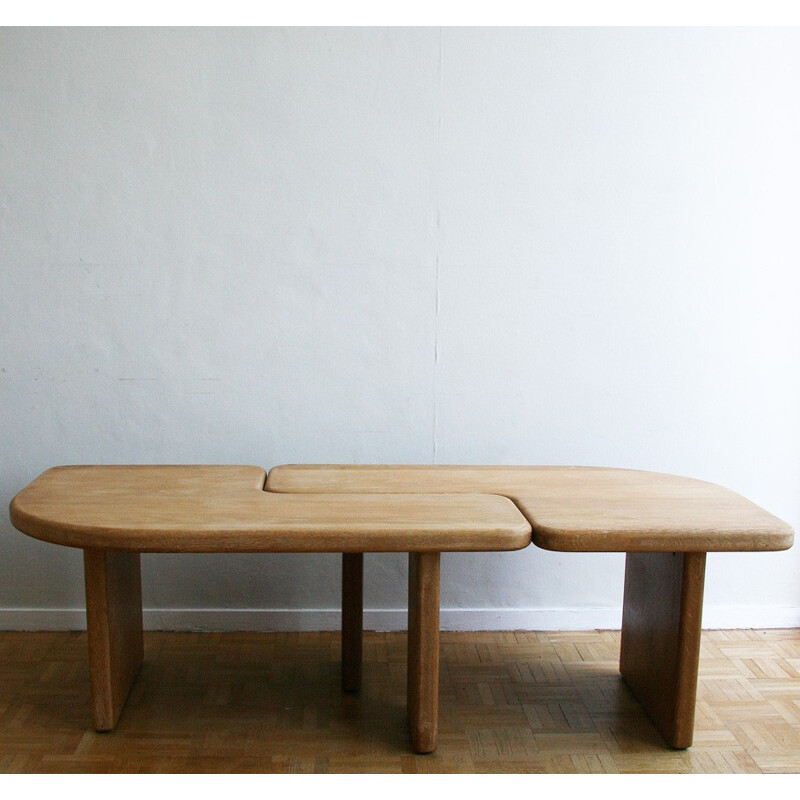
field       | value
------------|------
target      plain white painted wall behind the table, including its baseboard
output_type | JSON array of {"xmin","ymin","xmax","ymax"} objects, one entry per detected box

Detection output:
[{"xmin": 0, "ymin": 28, "xmax": 800, "ymax": 628}]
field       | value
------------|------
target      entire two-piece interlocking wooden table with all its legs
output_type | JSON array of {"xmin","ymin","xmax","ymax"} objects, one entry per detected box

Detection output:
[{"xmin": 11, "ymin": 466, "xmax": 793, "ymax": 752}]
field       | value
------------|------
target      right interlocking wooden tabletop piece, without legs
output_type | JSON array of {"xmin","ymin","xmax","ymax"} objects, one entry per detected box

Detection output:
[{"xmin": 267, "ymin": 464, "xmax": 793, "ymax": 552}]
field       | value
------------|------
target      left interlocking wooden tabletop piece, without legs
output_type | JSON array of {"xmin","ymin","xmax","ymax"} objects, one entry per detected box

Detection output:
[{"xmin": 11, "ymin": 466, "xmax": 530, "ymax": 553}]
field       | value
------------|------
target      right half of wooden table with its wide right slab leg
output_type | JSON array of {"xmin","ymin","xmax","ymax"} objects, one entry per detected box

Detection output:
[{"xmin": 267, "ymin": 465, "xmax": 793, "ymax": 748}]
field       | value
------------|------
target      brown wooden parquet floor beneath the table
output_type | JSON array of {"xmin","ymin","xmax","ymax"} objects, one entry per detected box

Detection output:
[{"xmin": 0, "ymin": 629, "xmax": 800, "ymax": 773}]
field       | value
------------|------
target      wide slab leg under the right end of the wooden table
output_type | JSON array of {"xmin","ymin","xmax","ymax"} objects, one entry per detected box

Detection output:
[{"xmin": 620, "ymin": 553, "xmax": 706, "ymax": 749}]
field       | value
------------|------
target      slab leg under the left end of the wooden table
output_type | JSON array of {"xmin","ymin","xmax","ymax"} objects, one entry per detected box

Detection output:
[{"xmin": 83, "ymin": 549, "xmax": 144, "ymax": 731}]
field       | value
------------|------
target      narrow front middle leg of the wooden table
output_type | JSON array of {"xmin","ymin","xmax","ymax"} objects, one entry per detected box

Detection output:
[{"xmin": 408, "ymin": 553, "xmax": 440, "ymax": 753}]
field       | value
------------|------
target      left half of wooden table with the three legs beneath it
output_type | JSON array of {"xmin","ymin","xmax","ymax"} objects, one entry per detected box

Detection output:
[{"xmin": 11, "ymin": 466, "xmax": 531, "ymax": 753}]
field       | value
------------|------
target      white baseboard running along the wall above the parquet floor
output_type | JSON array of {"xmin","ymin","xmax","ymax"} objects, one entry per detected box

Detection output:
[{"xmin": 0, "ymin": 606, "xmax": 800, "ymax": 632}]
